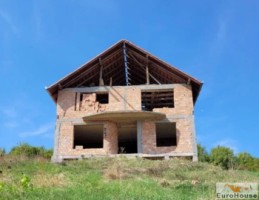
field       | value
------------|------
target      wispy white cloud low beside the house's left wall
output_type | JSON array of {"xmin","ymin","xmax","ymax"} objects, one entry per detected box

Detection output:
[{"xmin": 19, "ymin": 123, "xmax": 54, "ymax": 137}]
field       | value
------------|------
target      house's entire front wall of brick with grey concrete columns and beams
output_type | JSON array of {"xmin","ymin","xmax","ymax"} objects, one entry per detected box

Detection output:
[{"xmin": 52, "ymin": 84, "xmax": 197, "ymax": 162}]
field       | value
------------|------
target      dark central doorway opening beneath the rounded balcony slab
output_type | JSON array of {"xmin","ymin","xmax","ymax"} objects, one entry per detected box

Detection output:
[{"xmin": 118, "ymin": 123, "xmax": 138, "ymax": 154}]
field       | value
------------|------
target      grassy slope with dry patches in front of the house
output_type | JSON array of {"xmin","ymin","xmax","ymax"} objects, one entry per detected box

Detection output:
[{"xmin": 0, "ymin": 157, "xmax": 259, "ymax": 200}]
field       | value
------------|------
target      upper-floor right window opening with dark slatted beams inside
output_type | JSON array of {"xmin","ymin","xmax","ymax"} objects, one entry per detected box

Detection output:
[{"xmin": 141, "ymin": 89, "xmax": 174, "ymax": 111}]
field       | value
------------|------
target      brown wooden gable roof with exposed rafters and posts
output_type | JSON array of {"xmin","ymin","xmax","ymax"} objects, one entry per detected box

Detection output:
[{"xmin": 46, "ymin": 40, "xmax": 203, "ymax": 103}]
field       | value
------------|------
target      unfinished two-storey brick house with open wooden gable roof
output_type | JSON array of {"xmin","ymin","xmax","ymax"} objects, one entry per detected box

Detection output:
[{"xmin": 47, "ymin": 40, "xmax": 202, "ymax": 162}]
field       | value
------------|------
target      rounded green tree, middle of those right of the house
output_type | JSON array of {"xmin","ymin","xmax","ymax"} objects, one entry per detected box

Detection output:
[{"xmin": 210, "ymin": 146, "xmax": 235, "ymax": 169}]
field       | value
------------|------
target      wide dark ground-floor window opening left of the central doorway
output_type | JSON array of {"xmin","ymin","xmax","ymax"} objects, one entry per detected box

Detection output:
[{"xmin": 73, "ymin": 124, "xmax": 103, "ymax": 149}]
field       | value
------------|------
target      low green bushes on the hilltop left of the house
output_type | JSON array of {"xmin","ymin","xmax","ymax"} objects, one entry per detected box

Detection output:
[{"xmin": 10, "ymin": 143, "xmax": 52, "ymax": 158}]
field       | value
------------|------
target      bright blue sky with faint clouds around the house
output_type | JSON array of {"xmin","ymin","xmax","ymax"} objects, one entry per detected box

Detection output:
[{"xmin": 0, "ymin": 0, "xmax": 259, "ymax": 157}]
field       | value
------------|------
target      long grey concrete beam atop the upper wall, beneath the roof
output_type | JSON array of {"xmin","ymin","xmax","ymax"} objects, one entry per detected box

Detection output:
[{"xmin": 64, "ymin": 83, "xmax": 187, "ymax": 93}]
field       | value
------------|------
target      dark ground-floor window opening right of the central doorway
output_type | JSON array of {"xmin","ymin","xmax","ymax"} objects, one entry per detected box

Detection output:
[{"xmin": 156, "ymin": 123, "xmax": 177, "ymax": 147}]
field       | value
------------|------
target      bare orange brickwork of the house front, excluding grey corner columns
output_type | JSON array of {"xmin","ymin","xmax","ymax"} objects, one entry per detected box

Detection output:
[{"xmin": 55, "ymin": 84, "xmax": 198, "ymax": 162}]
